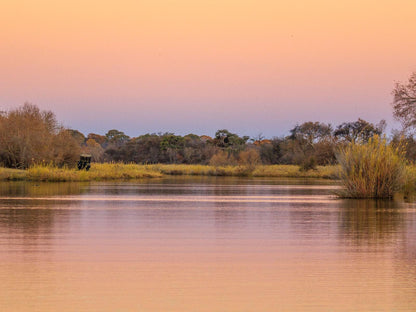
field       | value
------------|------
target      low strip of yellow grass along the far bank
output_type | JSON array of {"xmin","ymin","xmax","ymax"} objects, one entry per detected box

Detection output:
[{"xmin": 0, "ymin": 163, "xmax": 338, "ymax": 182}]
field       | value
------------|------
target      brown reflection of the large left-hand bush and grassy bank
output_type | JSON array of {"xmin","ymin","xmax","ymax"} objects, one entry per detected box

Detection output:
[{"xmin": 0, "ymin": 182, "xmax": 87, "ymax": 251}]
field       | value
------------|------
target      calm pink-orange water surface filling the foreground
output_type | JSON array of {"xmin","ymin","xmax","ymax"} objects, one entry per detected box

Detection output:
[{"xmin": 0, "ymin": 178, "xmax": 416, "ymax": 311}]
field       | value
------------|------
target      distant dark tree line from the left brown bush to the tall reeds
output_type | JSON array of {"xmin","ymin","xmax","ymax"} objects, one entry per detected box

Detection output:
[{"xmin": 68, "ymin": 119, "xmax": 385, "ymax": 168}]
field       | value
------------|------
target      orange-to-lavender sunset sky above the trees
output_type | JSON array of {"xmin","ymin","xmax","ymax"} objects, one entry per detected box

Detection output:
[{"xmin": 0, "ymin": 0, "xmax": 416, "ymax": 138}]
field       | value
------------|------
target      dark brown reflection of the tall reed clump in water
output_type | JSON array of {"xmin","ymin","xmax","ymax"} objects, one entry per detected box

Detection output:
[{"xmin": 340, "ymin": 199, "xmax": 402, "ymax": 245}]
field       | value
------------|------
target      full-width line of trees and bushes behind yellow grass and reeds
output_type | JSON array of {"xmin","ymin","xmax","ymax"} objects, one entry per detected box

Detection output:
[{"xmin": 0, "ymin": 73, "xmax": 416, "ymax": 170}]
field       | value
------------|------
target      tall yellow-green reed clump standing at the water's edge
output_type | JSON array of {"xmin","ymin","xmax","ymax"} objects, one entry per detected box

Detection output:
[{"xmin": 337, "ymin": 136, "xmax": 406, "ymax": 198}]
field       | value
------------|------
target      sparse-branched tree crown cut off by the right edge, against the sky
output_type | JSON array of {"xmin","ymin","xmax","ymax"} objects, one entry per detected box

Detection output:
[{"xmin": 392, "ymin": 72, "xmax": 416, "ymax": 131}]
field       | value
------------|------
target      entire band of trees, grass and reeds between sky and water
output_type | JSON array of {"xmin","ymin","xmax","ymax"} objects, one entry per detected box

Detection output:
[{"xmin": 0, "ymin": 73, "xmax": 416, "ymax": 199}]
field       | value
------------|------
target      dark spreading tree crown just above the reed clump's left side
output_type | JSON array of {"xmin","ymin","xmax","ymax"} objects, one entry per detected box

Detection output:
[{"xmin": 334, "ymin": 118, "xmax": 386, "ymax": 143}]
